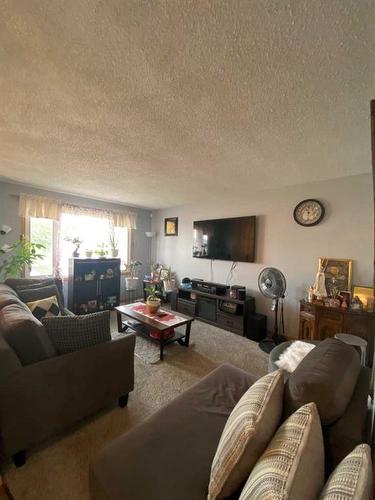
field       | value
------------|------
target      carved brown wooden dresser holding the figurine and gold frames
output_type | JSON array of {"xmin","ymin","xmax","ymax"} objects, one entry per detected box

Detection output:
[{"xmin": 298, "ymin": 300, "xmax": 375, "ymax": 366}]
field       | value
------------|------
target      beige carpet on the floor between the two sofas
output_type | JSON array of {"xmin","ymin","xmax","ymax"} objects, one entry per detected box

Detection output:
[{"xmin": 4, "ymin": 321, "xmax": 268, "ymax": 500}]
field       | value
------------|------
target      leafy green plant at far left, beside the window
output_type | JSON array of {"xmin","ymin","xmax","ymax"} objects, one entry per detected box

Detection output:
[{"xmin": 0, "ymin": 238, "xmax": 45, "ymax": 282}]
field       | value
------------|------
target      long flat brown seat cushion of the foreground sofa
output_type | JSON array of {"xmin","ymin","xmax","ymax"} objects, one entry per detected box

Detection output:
[{"xmin": 90, "ymin": 364, "xmax": 256, "ymax": 500}]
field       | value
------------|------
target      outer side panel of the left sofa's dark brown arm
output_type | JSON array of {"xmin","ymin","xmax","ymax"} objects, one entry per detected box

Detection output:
[{"xmin": 0, "ymin": 334, "xmax": 135, "ymax": 454}]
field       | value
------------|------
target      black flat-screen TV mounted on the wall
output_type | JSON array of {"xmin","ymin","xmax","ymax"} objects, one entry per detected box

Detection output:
[{"xmin": 193, "ymin": 215, "xmax": 255, "ymax": 262}]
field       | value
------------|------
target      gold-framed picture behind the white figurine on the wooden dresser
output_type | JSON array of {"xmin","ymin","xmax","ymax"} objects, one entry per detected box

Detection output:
[{"xmin": 319, "ymin": 257, "xmax": 353, "ymax": 295}]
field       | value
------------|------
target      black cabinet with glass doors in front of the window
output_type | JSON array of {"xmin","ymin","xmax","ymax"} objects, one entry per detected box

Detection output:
[{"xmin": 68, "ymin": 258, "xmax": 121, "ymax": 314}]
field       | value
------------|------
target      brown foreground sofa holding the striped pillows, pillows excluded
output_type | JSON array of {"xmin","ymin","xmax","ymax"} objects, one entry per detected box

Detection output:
[{"xmin": 90, "ymin": 339, "xmax": 370, "ymax": 500}]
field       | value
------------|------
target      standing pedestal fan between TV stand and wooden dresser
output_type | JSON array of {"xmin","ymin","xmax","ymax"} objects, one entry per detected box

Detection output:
[{"xmin": 258, "ymin": 267, "xmax": 286, "ymax": 352}]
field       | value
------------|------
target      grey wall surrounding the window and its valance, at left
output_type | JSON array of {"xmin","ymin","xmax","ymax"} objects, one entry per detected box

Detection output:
[{"xmin": 0, "ymin": 181, "xmax": 151, "ymax": 296}]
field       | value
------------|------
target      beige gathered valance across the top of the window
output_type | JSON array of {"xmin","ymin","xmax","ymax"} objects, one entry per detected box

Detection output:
[{"xmin": 19, "ymin": 193, "xmax": 137, "ymax": 229}]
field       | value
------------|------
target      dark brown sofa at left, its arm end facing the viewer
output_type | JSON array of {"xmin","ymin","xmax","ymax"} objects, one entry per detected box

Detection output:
[{"xmin": 0, "ymin": 284, "xmax": 135, "ymax": 465}]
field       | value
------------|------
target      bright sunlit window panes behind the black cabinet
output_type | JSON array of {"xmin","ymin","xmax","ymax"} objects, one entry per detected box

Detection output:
[{"xmin": 28, "ymin": 213, "xmax": 130, "ymax": 277}]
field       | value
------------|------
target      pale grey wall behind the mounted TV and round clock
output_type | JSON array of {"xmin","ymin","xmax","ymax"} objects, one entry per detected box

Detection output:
[{"xmin": 153, "ymin": 174, "xmax": 374, "ymax": 337}]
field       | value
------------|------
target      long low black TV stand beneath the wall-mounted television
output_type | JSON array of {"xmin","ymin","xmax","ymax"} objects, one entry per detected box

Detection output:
[{"xmin": 171, "ymin": 285, "xmax": 255, "ymax": 337}]
